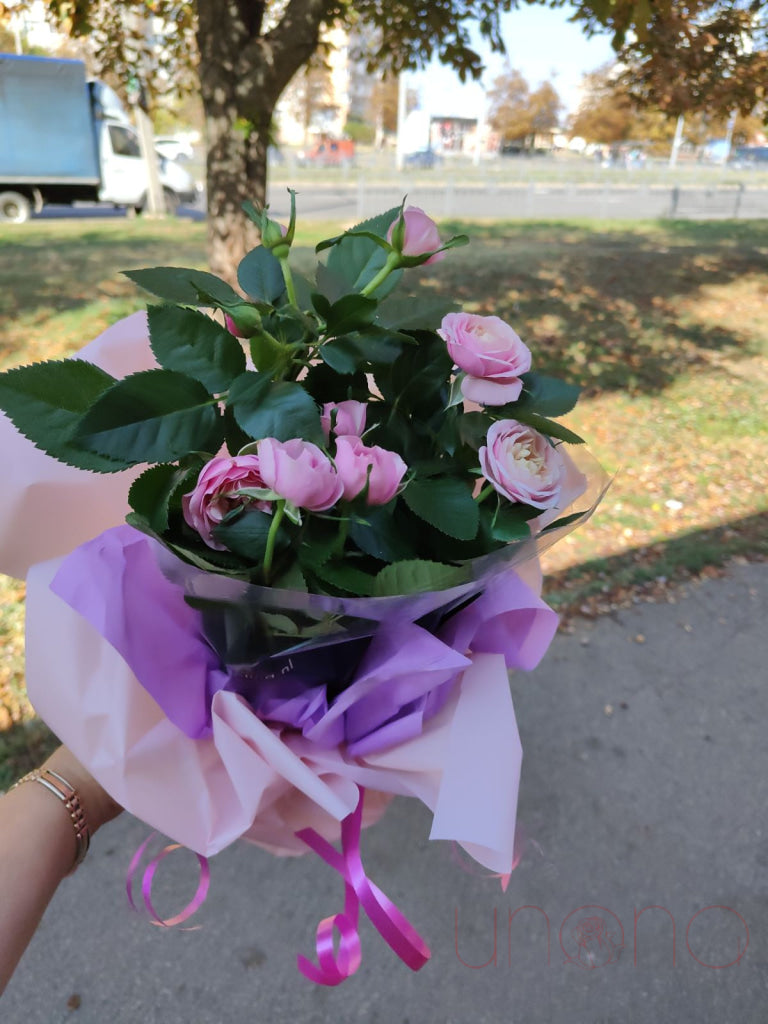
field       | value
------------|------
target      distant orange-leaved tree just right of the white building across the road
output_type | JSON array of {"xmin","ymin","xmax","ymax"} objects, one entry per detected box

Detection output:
[{"xmin": 488, "ymin": 65, "xmax": 562, "ymax": 147}]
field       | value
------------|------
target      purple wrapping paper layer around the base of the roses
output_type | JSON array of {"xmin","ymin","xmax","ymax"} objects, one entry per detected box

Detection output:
[{"xmin": 51, "ymin": 526, "xmax": 557, "ymax": 756}]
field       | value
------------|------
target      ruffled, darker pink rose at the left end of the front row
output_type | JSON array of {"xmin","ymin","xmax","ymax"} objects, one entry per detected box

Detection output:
[{"xmin": 181, "ymin": 455, "xmax": 271, "ymax": 551}]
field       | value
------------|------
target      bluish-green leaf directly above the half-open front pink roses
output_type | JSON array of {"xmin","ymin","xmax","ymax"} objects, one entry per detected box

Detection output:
[{"xmin": 228, "ymin": 373, "xmax": 324, "ymax": 443}]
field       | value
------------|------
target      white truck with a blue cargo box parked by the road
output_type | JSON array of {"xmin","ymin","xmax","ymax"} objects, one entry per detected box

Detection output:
[{"xmin": 0, "ymin": 53, "xmax": 197, "ymax": 223}]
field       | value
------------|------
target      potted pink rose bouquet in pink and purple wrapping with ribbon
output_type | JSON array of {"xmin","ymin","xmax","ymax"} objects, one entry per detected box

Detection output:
[{"xmin": 0, "ymin": 193, "xmax": 603, "ymax": 984}]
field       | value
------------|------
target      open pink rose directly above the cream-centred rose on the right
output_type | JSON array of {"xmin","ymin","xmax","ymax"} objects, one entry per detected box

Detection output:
[{"xmin": 437, "ymin": 313, "xmax": 530, "ymax": 406}]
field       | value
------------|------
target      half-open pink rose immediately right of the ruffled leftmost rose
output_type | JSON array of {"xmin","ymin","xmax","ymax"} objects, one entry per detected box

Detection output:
[{"xmin": 258, "ymin": 437, "xmax": 344, "ymax": 512}]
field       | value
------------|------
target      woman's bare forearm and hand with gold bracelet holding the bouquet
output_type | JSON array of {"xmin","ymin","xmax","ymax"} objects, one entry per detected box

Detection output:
[{"xmin": 0, "ymin": 746, "xmax": 121, "ymax": 994}]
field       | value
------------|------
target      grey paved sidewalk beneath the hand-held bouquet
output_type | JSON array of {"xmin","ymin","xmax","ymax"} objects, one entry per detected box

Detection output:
[{"xmin": 0, "ymin": 564, "xmax": 768, "ymax": 1024}]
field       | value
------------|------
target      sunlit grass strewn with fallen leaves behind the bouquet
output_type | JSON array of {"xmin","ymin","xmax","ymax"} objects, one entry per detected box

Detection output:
[{"xmin": 0, "ymin": 214, "xmax": 768, "ymax": 774}]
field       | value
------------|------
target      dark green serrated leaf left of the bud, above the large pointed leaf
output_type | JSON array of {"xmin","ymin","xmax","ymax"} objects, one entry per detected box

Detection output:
[{"xmin": 147, "ymin": 306, "xmax": 246, "ymax": 394}]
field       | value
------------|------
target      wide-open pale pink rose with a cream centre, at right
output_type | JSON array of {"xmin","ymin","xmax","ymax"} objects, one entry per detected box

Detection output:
[{"xmin": 478, "ymin": 420, "xmax": 566, "ymax": 509}]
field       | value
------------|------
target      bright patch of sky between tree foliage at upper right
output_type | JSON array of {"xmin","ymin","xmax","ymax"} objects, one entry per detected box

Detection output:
[{"xmin": 409, "ymin": 4, "xmax": 613, "ymax": 117}]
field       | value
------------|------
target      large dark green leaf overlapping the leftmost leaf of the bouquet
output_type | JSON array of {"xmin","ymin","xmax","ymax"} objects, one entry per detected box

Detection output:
[{"xmin": 75, "ymin": 370, "xmax": 224, "ymax": 466}]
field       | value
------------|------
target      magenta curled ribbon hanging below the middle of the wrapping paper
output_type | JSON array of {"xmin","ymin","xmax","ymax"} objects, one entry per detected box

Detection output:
[{"xmin": 296, "ymin": 787, "xmax": 432, "ymax": 985}]
